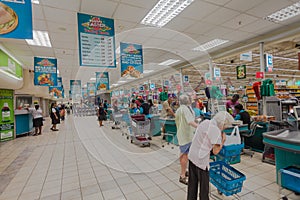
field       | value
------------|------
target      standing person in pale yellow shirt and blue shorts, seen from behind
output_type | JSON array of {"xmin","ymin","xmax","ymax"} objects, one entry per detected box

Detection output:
[{"xmin": 175, "ymin": 95, "xmax": 197, "ymax": 185}]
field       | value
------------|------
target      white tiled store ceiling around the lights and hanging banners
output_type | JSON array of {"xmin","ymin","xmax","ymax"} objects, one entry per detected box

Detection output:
[{"xmin": 0, "ymin": 0, "xmax": 300, "ymax": 90}]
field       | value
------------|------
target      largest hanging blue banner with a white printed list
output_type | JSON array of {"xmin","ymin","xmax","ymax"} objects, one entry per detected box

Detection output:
[{"xmin": 77, "ymin": 13, "xmax": 116, "ymax": 68}]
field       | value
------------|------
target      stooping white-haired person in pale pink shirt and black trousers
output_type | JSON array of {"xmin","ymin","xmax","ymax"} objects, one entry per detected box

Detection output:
[{"xmin": 187, "ymin": 111, "xmax": 234, "ymax": 200}]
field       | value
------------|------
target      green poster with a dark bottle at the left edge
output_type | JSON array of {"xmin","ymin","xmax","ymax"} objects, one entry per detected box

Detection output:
[{"xmin": 0, "ymin": 89, "xmax": 15, "ymax": 142}]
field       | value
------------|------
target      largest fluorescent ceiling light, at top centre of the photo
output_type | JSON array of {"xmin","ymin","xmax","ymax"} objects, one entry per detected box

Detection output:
[{"xmin": 141, "ymin": 0, "xmax": 194, "ymax": 27}]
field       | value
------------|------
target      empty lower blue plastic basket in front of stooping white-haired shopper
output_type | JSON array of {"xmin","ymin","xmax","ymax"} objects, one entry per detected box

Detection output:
[{"xmin": 209, "ymin": 161, "xmax": 246, "ymax": 199}]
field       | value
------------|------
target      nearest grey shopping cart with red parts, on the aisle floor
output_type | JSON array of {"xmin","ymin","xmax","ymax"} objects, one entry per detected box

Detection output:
[{"xmin": 130, "ymin": 115, "xmax": 150, "ymax": 146}]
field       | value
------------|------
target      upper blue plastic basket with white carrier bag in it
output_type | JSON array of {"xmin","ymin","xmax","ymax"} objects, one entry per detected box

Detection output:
[{"xmin": 216, "ymin": 143, "xmax": 244, "ymax": 164}]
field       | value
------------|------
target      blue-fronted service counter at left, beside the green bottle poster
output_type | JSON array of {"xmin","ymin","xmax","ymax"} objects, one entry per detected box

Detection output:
[{"xmin": 15, "ymin": 110, "xmax": 33, "ymax": 137}]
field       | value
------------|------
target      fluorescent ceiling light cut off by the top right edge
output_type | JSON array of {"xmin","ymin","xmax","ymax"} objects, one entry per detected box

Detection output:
[{"xmin": 264, "ymin": 2, "xmax": 300, "ymax": 22}]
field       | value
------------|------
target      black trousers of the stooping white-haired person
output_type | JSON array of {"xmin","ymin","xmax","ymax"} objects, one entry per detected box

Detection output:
[{"xmin": 187, "ymin": 161, "xmax": 209, "ymax": 200}]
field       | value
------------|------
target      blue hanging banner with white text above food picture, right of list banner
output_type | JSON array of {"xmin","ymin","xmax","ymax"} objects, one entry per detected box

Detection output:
[{"xmin": 120, "ymin": 42, "xmax": 143, "ymax": 78}]
